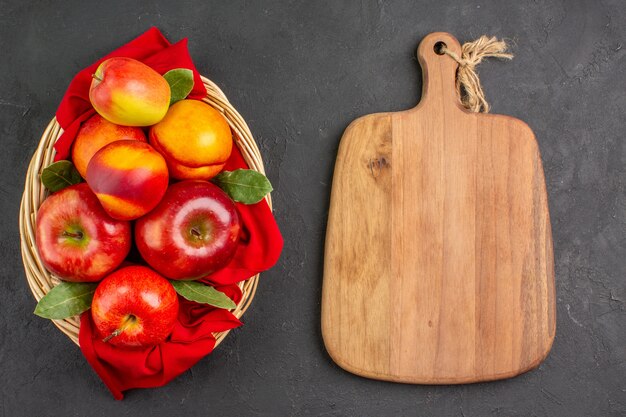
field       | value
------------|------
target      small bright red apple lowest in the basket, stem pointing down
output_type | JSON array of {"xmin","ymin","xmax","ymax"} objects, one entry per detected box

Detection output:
[{"xmin": 91, "ymin": 266, "xmax": 178, "ymax": 346}]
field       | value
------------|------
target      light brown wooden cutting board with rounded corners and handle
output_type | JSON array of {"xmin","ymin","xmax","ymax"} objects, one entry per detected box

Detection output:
[{"xmin": 322, "ymin": 33, "xmax": 556, "ymax": 384}]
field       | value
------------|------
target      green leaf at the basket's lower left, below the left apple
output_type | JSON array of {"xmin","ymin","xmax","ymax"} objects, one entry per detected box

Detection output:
[{"xmin": 35, "ymin": 282, "xmax": 98, "ymax": 320}]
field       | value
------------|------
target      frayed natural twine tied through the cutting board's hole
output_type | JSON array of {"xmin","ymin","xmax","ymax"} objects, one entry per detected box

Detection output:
[{"xmin": 441, "ymin": 35, "xmax": 513, "ymax": 113}]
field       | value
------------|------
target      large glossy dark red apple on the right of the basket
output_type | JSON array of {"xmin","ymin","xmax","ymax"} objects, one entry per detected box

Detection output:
[{"xmin": 135, "ymin": 180, "xmax": 240, "ymax": 279}]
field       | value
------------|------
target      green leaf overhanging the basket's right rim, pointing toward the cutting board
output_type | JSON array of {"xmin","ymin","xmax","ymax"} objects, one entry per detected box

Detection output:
[{"xmin": 212, "ymin": 169, "xmax": 273, "ymax": 204}]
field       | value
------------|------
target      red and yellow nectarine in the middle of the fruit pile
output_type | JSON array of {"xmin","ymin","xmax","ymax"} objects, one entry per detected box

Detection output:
[{"xmin": 87, "ymin": 140, "xmax": 169, "ymax": 220}]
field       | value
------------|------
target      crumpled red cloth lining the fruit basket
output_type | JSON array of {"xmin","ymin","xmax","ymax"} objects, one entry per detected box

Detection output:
[{"xmin": 55, "ymin": 28, "xmax": 283, "ymax": 399}]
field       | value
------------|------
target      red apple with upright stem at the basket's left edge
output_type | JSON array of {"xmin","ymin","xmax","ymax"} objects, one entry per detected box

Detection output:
[{"xmin": 36, "ymin": 183, "xmax": 131, "ymax": 282}]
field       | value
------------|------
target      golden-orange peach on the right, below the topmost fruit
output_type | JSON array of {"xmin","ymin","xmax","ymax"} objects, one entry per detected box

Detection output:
[{"xmin": 148, "ymin": 100, "xmax": 233, "ymax": 180}]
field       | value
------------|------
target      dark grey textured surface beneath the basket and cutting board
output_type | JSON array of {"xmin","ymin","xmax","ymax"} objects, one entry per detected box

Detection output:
[{"xmin": 0, "ymin": 0, "xmax": 626, "ymax": 417}]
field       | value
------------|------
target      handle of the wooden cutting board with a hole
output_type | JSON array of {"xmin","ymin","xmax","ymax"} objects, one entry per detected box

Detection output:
[{"xmin": 416, "ymin": 32, "xmax": 465, "ymax": 111}]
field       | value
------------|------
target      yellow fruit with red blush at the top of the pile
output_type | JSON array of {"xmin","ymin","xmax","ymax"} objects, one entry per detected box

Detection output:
[{"xmin": 89, "ymin": 57, "xmax": 171, "ymax": 126}]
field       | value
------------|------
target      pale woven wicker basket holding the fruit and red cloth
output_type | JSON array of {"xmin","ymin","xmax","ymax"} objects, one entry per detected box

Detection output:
[{"xmin": 20, "ymin": 77, "xmax": 272, "ymax": 346}]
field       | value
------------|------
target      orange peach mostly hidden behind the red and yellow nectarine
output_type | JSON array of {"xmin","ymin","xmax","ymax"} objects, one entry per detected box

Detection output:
[{"xmin": 72, "ymin": 114, "xmax": 147, "ymax": 178}]
